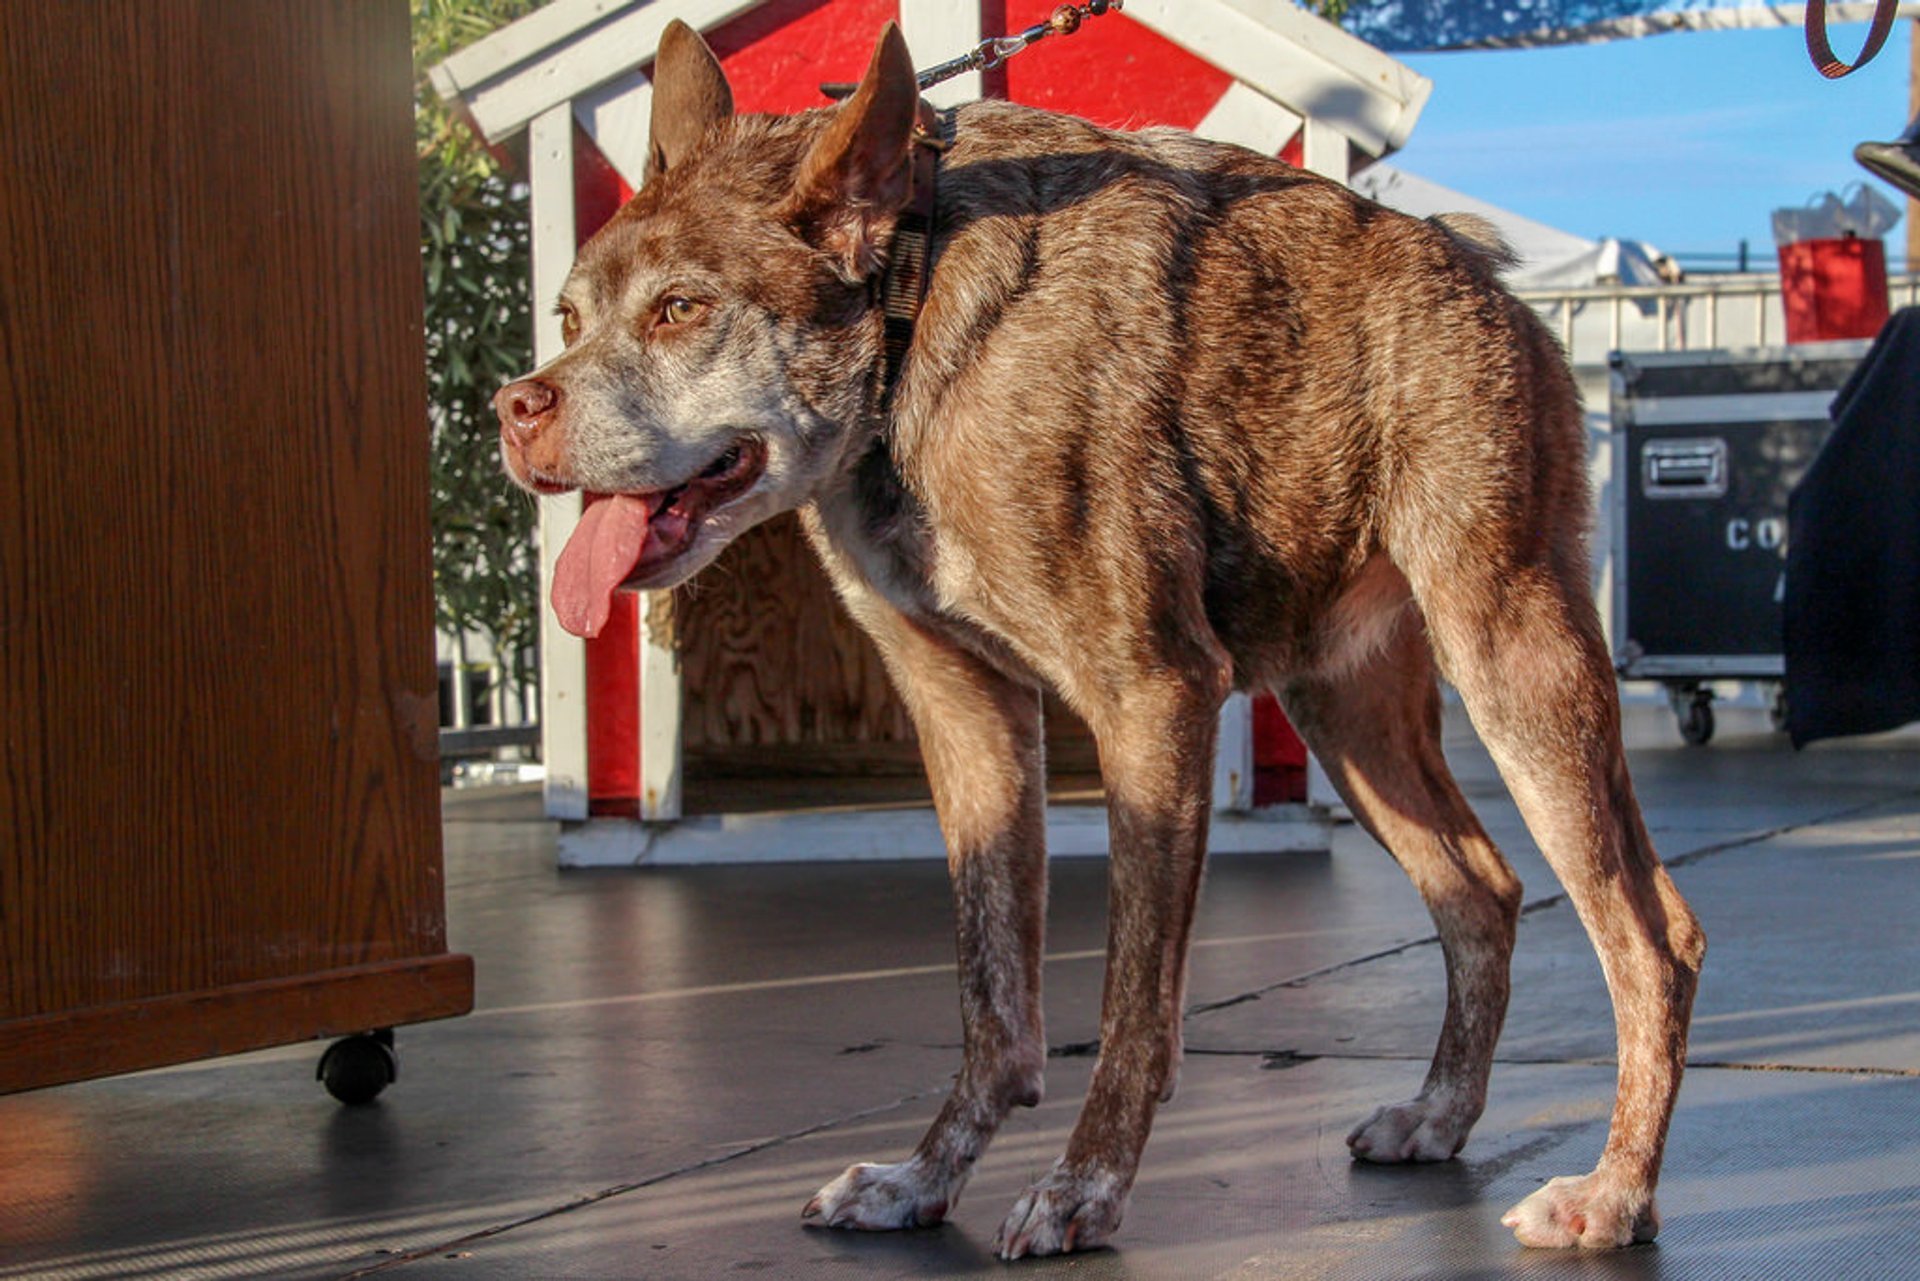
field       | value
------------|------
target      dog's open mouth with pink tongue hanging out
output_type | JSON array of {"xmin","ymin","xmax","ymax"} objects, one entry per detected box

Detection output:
[{"xmin": 553, "ymin": 436, "xmax": 766, "ymax": 636}]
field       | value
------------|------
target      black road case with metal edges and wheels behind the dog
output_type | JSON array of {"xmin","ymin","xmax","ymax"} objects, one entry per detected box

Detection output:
[{"xmin": 1611, "ymin": 342, "xmax": 1868, "ymax": 743}]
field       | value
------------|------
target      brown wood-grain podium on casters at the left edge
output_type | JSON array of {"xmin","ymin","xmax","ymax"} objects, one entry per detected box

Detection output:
[{"xmin": 0, "ymin": 0, "xmax": 472, "ymax": 1091}]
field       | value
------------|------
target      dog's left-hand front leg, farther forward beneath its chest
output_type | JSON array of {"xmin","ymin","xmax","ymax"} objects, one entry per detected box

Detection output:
[{"xmin": 803, "ymin": 599, "xmax": 1046, "ymax": 1229}]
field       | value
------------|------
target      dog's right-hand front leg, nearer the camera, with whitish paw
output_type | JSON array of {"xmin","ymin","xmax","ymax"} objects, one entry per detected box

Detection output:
[{"xmin": 996, "ymin": 668, "xmax": 1225, "ymax": 1260}]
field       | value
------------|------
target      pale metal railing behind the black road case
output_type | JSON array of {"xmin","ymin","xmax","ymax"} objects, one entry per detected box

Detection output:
[{"xmin": 1515, "ymin": 271, "xmax": 1920, "ymax": 365}]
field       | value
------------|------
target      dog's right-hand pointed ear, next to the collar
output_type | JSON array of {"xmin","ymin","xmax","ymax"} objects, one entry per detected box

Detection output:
[{"xmin": 783, "ymin": 23, "xmax": 920, "ymax": 280}]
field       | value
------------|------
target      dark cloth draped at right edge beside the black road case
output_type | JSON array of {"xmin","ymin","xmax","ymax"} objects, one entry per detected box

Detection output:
[{"xmin": 1784, "ymin": 307, "xmax": 1920, "ymax": 747}]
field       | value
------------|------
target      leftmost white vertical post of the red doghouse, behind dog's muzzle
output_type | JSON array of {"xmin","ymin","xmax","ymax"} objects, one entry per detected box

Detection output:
[{"xmin": 526, "ymin": 104, "xmax": 588, "ymax": 820}]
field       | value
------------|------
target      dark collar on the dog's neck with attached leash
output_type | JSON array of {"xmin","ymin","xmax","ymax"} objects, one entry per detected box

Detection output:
[{"xmin": 820, "ymin": 0, "xmax": 1125, "ymax": 398}]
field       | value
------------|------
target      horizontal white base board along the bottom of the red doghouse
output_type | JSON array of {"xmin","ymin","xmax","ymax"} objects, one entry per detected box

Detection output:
[{"xmin": 559, "ymin": 805, "xmax": 1332, "ymax": 868}]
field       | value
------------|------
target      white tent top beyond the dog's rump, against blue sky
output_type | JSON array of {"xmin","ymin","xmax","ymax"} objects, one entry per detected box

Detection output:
[{"xmin": 1352, "ymin": 163, "xmax": 1661, "ymax": 288}]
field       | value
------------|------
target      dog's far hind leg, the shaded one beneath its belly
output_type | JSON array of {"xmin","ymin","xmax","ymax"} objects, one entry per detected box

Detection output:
[{"xmin": 1279, "ymin": 587, "xmax": 1521, "ymax": 1162}]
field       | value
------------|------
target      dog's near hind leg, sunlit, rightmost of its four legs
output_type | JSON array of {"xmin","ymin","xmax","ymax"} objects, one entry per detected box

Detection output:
[{"xmin": 1415, "ymin": 556, "xmax": 1707, "ymax": 1248}]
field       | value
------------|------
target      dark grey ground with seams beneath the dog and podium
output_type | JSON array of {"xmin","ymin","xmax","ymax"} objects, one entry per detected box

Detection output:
[{"xmin": 0, "ymin": 707, "xmax": 1920, "ymax": 1281}]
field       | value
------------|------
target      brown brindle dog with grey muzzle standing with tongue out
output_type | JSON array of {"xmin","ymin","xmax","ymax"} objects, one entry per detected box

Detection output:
[{"xmin": 495, "ymin": 25, "xmax": 1705, "ymax": 1260}]
